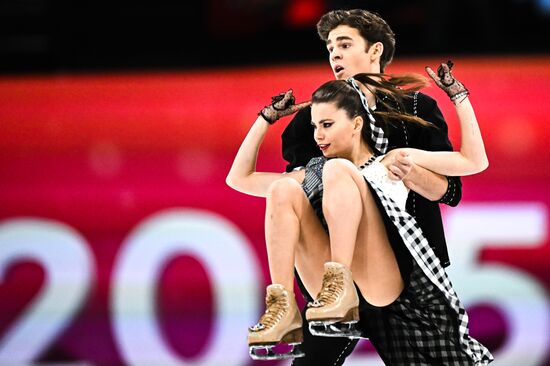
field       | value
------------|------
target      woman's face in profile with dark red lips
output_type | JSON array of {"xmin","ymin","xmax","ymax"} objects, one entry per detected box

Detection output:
[{"xmin": 311, "ymin": 102, "xmax": 361, "ymax": 158}]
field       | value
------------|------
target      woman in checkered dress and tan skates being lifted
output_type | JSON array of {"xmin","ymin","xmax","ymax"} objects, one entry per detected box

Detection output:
[{"xmin": 227, "ymin": 64, "xmax": 492, "ymax": 365}]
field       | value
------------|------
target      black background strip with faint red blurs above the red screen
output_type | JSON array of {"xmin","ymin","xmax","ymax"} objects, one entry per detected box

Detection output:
[{"xmin": 0, "ymin": 0, "xmax": 550, "ymax": 73}]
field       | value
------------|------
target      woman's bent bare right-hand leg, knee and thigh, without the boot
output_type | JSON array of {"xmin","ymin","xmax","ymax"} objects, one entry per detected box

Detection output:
[{"xmin": 323, "ymin": 159, "xmax": 403, "ymax": 306}]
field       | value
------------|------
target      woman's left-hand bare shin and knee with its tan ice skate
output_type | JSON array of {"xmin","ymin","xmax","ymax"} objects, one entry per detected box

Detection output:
[{"xmin": 248, "ymin": 177, "xmax": 329, "ymax": 359}]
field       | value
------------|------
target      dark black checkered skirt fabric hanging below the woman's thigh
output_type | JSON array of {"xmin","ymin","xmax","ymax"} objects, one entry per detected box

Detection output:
[{"xmin": 359, "ymin": 264, "xmax": 474, "ymax": 366}]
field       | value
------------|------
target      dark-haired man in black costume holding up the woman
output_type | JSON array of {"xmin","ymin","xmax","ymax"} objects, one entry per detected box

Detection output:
[{"xmin": 282, "ymin": 9, "xmax": 462, "ymax": 366}]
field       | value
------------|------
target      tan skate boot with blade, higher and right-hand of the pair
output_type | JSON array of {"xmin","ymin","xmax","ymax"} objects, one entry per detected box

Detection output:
[{"xmin": 306, "ymin": 262, "xmax": 360, "ymax": 338}]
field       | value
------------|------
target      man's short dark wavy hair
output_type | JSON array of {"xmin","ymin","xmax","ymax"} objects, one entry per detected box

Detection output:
[{"xmin": 317, "ymin": 9, "xmax": 395, "ymax": 72}]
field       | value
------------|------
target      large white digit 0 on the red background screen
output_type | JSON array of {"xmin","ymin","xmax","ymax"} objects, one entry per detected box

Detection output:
[{"xmin": 111, "ymin": 210, "xmax": 261, "ymax": 365}]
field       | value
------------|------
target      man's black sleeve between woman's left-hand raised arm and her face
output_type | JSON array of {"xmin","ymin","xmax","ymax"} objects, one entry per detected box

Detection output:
[{"xmin": 281, "ymin": 107, "xmax": 321, "ymax": 172}]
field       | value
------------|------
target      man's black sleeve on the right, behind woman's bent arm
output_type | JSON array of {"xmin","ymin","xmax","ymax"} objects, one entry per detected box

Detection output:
[{"xmin": 413, "ymin": 93, "xmax": 462, "ymax": 207}]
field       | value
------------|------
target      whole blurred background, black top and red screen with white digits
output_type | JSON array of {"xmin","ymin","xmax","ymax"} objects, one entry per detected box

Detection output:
[{"xmin": 0, "ymin": 0, "xmax": 550, "ymax": 366}]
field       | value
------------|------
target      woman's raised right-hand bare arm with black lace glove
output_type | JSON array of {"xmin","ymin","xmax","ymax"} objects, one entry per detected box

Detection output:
[{"xmin": 402, "ymin": 63, "xmax": 489, "ymax": 176}]
